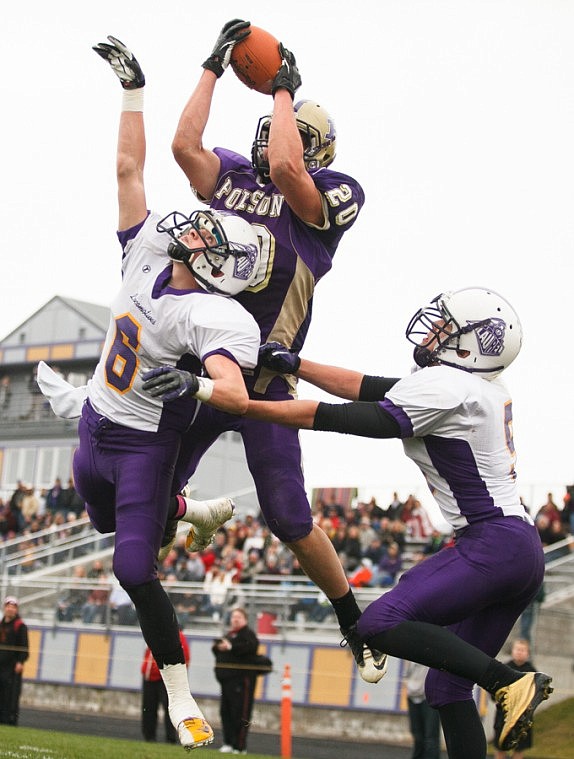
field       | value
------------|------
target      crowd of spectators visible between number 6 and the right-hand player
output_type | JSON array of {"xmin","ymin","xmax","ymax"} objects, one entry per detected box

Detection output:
[{"xmin": 153, "ymin": 493, "xmax": 445, "ymax": 625}]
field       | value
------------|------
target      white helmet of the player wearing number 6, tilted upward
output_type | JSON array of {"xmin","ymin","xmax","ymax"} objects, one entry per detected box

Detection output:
[{"xmin": 157, "ymin": 214, "xmax": 261, "ymax": 295}]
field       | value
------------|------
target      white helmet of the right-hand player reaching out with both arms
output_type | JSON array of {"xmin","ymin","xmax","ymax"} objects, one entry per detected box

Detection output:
[{"xmin": 406, "ymin": 287, "xmax": 522, "ymax": 379}]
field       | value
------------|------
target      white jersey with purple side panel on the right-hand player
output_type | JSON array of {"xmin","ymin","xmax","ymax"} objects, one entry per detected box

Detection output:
[{"xmin": 381, "ymin": 366, "xmax": 531, "ymax": 530}]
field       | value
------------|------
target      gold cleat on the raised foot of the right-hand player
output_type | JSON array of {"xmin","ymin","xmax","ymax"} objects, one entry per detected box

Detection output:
[{"xmin": 494, "ymin": 672, "xmax": 553, "ymax": 751}]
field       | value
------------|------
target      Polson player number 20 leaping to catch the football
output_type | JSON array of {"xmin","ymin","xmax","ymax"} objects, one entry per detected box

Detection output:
[{"xmin": 164, "ymin": 19, "xmax": 386, "ymax": 682}]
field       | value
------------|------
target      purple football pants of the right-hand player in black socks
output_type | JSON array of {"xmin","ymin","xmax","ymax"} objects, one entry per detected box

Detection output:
[{"xmin": 358, "ymin": 517, "xmax": 544, "ymax": 708}]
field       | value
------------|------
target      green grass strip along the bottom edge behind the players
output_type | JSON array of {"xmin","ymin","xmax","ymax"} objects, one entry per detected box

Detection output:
[{"xmin": 0, "ymin": 698, "xmax": 574, "ymax": 759}]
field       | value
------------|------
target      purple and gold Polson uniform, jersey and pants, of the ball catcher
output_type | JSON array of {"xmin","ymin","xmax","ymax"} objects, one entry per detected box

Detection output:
[{"xmin": 175, "ymin": 148, "xmax": 364, "ymax": 543}]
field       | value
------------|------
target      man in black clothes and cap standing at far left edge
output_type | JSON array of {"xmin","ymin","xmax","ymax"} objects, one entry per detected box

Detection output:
[{"xmin": 0, "ymin": 596, "xmax": 29, "ymax": 725}]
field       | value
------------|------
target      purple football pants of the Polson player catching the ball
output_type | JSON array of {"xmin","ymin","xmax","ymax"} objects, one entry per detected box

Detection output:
[{"xmin": 174, "ymin": 394, "xmax": 313, "ymax": 543}]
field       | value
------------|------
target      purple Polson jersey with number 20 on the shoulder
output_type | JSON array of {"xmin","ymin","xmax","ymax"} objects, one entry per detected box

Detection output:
[{"xmin": 206, "ymin": 148, "xmax": 365, "ymax": 392}]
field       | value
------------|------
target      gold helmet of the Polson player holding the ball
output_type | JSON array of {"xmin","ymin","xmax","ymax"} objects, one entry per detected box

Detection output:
[{"xmin": 251, "ymin": 100, "xmax": 337, "ymax": 179}]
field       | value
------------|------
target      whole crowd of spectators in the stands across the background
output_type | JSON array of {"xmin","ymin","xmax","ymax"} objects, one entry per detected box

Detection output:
[{"xmin": 4, "ymin": 479, "xmax": 574, "ymax": 625}]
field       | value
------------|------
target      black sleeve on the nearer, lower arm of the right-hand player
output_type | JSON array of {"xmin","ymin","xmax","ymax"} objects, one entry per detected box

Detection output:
[{"xmin": 313, "ymin": 401, "xmax": 401, "ymax": 438}]
